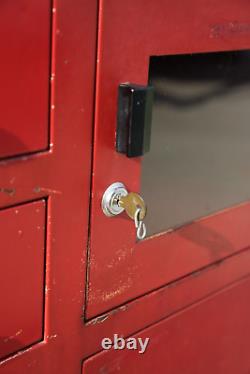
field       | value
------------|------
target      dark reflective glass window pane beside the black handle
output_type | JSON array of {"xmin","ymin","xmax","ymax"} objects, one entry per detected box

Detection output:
[{"xmin": 141, "ymin": 51, "xmax": 250, "ymax": 235}]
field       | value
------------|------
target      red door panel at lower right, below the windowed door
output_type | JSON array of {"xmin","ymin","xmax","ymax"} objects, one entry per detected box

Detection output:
[{"xmin": 82, "ymin": 278, "xmax": 250, "ymax": 374}]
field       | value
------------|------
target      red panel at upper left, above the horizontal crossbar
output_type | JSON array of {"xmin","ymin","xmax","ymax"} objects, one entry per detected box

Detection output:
[{"xmin": 0, "ymin": 0, "xmax": 51, "ymax": 158}]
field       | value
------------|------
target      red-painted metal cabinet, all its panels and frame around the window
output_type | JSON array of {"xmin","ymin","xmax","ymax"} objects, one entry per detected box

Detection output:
[{"xmin": 0, "ymin": 0, "xmax": 250, "ymax": 374}]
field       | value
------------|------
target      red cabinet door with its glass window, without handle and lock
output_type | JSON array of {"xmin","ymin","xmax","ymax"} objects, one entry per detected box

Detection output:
[{"xmin": 86, "ymin": 0, "xmax": 250, "ymax": 318}]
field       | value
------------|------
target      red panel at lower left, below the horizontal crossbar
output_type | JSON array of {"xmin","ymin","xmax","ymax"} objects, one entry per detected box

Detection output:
[{"xmin": 0, "ymin": 200, "xmax": 46, "ymax": 359}]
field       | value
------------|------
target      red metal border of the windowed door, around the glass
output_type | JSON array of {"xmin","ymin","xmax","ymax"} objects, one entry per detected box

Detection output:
[{"xmin": 87, "ymin": 0, "xmax": 250, "ymax": 318}]
